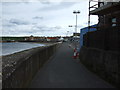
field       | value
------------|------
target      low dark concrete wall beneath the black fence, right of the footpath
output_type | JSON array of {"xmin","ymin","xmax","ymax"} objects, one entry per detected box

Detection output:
[{"xmin": 80, "ymin": 46, "xmax": 120, "ymax": 88}]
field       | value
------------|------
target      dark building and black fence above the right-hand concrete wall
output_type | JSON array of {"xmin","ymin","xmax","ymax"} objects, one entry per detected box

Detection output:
[{"xmin": 85, "ymin": 0, "xmax": 120, "ymax": 52}]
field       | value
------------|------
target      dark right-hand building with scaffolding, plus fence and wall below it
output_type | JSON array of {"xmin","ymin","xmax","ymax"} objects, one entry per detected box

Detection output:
[{"xmin": 80, "ymin": 0, "xmax": 120, "ymax": 88}]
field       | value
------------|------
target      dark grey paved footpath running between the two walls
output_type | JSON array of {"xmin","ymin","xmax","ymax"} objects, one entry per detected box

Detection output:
[{"xmin": 30, "ymin": 43, "xmax": 113, "ymax": 88}]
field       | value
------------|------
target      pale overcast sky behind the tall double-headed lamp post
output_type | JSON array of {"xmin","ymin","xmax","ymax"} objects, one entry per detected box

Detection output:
[{"xmin": 0, "ymin": 0, "xmax": 98, "ymax": 36}]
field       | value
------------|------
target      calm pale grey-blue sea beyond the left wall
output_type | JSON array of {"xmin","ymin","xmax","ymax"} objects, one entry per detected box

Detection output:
[{"xmin": 0, "ymin": 42, "xmax": 45, "ymax": 56}]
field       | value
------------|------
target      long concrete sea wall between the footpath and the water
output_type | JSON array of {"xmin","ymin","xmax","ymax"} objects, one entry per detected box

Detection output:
[{"xmin": 2, "ymin": 44, "xmax": 60, "ymax": 88}]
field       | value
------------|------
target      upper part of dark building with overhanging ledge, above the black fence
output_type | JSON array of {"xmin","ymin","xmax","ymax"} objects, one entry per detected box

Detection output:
[{"xmin": 90, "ymin": 0, "xmax": 120, "ymax": 28}]
